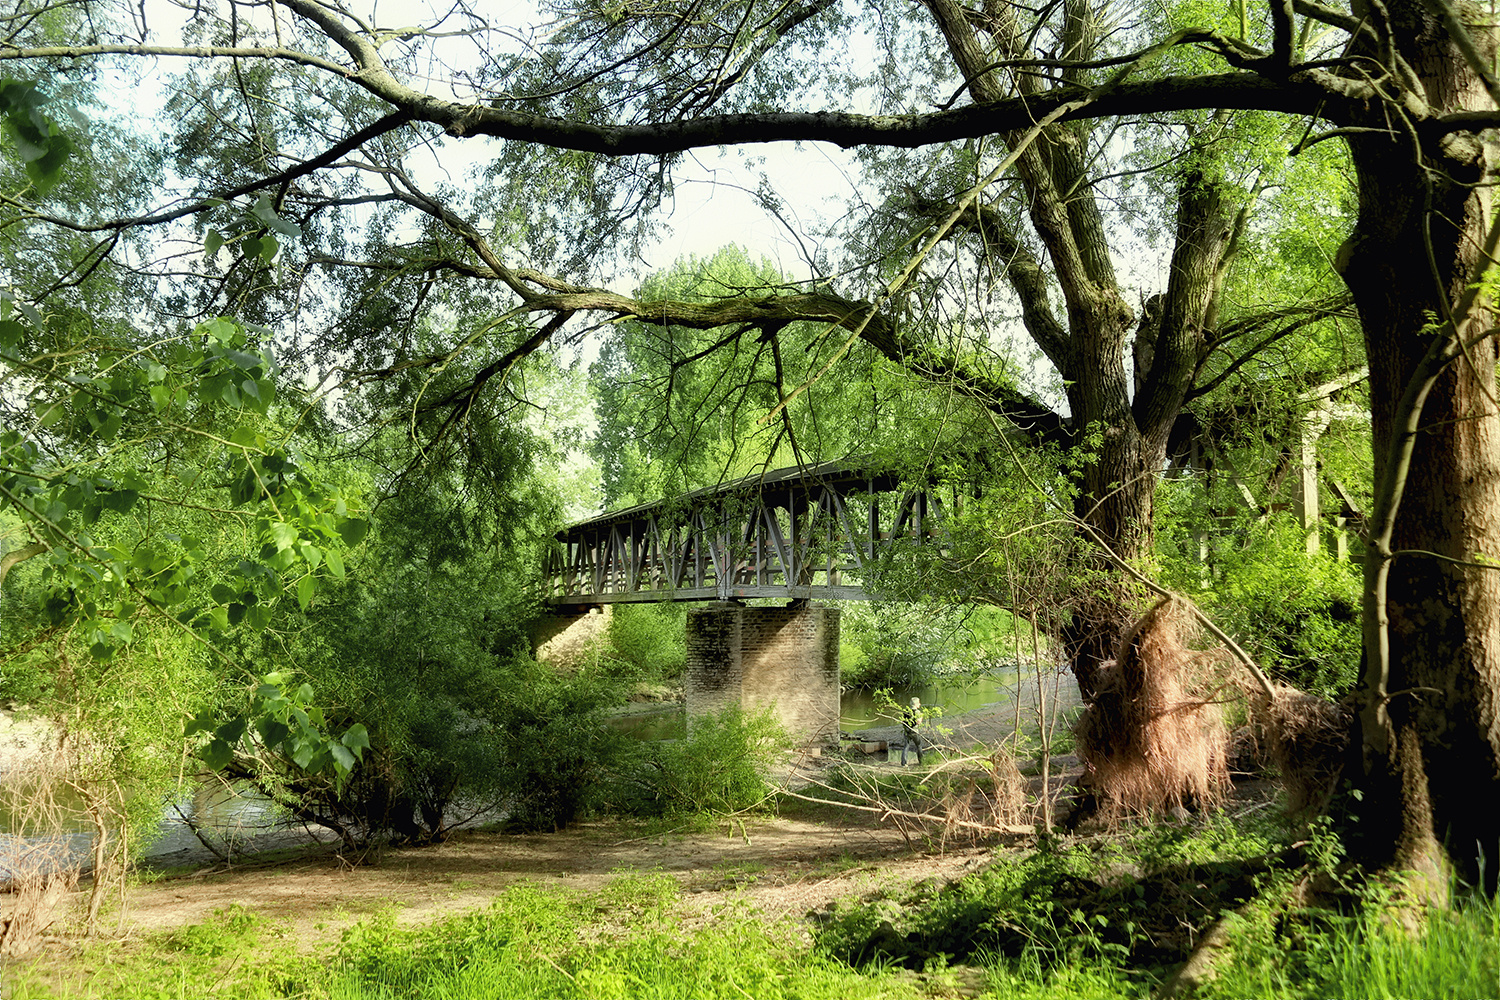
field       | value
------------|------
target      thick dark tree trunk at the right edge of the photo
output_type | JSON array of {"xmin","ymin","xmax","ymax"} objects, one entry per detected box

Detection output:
[{"xmin": 1341, "ymin": 0, "xmax": 1500, "ymax": 877}]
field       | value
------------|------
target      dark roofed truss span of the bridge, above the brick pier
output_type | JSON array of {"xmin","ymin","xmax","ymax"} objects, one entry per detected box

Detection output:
[{"xmin": 545, "ymin": 460, "xmax": 945, "ymax": 606}]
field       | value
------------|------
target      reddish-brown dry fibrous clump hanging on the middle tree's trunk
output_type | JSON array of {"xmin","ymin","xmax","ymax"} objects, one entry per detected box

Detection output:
[{"xmin": 1074, "ymin": 598, "xmax": 1229, "ymax": 819}]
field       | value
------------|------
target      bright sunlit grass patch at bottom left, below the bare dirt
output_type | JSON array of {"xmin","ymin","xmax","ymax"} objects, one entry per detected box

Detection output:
[{"xmin": 6, "ymin": 873, "xmax": 932, "ymax": 1000}]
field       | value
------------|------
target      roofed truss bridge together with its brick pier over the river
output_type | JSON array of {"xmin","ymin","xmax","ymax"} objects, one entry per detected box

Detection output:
[{"xmin": 539, "ymin": 459, "xmax": 945, "ymax": 742}]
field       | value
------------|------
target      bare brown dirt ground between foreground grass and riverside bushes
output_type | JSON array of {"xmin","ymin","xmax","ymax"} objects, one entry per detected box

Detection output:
[{"xmin": 93, "ymin": 817, "xmax": 1026, "ymax": 945}]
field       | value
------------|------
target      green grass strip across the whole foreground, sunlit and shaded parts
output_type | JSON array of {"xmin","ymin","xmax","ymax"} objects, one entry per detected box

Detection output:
[{"xmin": 0, "ymin": 822, "xmax": 1500, "ymax": 1000}]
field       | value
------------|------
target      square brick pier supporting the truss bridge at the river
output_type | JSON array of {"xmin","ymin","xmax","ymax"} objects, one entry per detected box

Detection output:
[{"xmin": 683, "ymin": 601, "xmax": 840, "ymax": 745}]
